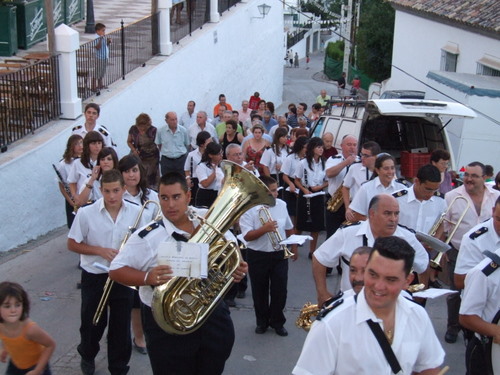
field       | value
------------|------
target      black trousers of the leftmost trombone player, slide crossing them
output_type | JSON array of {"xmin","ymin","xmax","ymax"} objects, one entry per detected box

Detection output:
[{"xmin": 77, "ymin": 270, "xmax": 134, "ymax": 375}]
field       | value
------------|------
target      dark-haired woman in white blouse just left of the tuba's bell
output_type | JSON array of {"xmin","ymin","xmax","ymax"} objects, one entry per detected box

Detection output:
[{"xmin": 195, "ymin": 142, "xmax": 224, "ymax": 207}]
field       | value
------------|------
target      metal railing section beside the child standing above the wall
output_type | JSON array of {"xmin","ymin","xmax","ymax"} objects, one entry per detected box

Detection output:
[{"xmin": 76, "ymin": 15, "xmax": 158, "ymax": 100}]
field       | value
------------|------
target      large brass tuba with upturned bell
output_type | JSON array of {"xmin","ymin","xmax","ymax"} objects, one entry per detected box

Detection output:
[{"xmin": 151, "ymin": 161, "xmax": 276, "ymax": 335}]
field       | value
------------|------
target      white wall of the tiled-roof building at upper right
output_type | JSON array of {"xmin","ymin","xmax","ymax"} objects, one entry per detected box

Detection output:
[{"xmin": 384, "ymin": 11, "xmax": 500, "ymax": 92}]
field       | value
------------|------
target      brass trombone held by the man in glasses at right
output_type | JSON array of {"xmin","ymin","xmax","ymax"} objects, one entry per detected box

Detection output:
[{"xmin": 417, "ymin": 196, "xmax": 470, "ymax": 271}]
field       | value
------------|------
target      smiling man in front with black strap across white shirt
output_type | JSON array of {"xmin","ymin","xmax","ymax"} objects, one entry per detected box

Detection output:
[{"xmin": 293, "ymin": 235, "xmax": 445, "ymax": 375}]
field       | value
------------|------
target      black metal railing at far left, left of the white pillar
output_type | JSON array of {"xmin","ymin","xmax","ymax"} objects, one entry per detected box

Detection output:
[{"xmin": 0, "ymin": 55, "xmax": 61, "ymax": 146}]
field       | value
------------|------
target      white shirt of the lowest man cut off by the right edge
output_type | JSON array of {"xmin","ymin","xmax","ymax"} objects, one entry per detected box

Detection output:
[{"xmin": 460, "ymin": 249, "xmax": 500, "ymax": 323}]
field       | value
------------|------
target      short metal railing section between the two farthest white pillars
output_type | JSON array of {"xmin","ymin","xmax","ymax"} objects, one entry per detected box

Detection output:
[{"xmin": 170, "ymin": 0, "xmax": 210, "ymax": 43}]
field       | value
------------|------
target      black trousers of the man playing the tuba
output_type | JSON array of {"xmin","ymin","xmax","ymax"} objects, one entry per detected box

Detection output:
[{"xmin": 141, "ymin": 302, "xmax": 234, "ymax": 375}]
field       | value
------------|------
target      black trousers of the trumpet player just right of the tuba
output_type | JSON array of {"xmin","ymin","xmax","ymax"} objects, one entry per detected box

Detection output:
[{"xmin": 247, "ymin": 249, "xmax": 288, "ymax": 328}]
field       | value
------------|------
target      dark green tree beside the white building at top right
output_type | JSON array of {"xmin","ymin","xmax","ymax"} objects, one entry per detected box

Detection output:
[{"xmin": 356, "ymin": 0, "xmax": 395, "ymax": 82}]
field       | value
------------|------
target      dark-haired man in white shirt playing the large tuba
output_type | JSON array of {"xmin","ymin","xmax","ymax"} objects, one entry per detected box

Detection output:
[{"xmin": 110, "ymin": 172, "xmax": 248, "ymax": 375}]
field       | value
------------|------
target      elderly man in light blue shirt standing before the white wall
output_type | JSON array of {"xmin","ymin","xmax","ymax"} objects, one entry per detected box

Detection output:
[{"xmin": 155, "ymin": 112, "xmax": 189, "ymax": 175}]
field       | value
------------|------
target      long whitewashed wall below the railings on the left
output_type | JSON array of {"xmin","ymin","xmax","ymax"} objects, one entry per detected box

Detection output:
[{"xmin": 0, "ymin": 0, "xmax": 286, "ymax": 251}]
